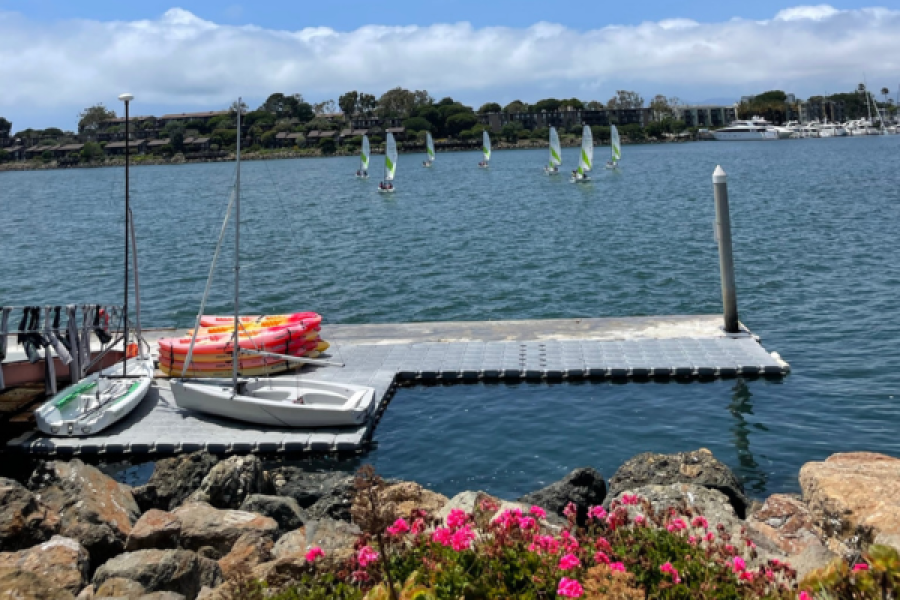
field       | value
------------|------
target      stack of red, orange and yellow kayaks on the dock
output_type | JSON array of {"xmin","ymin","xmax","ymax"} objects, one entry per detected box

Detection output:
[{"xmin": 159, "ymin": 312, "xmax": 329, "ymax": 378}]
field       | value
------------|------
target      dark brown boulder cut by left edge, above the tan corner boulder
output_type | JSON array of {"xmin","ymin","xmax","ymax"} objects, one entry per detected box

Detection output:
[{"xmin": 0, "ymin": 477, "xmax": 59, "ymax": 552}]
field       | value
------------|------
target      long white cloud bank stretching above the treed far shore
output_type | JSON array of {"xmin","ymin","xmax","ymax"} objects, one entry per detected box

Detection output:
[{"xmin": 0, "ymin": 6, "xmax": 900, "ymax": 127}]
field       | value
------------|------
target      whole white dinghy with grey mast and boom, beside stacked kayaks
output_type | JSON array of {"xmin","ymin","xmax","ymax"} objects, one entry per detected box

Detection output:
[{"xmin": 169, "ymin": 99, "xmax": 375, "ymax": 427}]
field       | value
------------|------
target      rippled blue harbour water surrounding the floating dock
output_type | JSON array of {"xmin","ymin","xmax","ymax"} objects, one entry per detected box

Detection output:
[{"xmin": 0, "ymin": 136, "xmax": 900, "ymax": 497}]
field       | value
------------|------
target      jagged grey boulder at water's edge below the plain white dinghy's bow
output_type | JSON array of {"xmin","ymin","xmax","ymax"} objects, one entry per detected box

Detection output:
[{"xmin": 188, "ymin": 455, "xmax": 273, "ymax": 508}]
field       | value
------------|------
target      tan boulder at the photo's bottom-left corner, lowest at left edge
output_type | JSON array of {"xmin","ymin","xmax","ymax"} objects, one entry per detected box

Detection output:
[{"xmin": 0, "ymin": 535, "xmax": 90, "ymax": 595}]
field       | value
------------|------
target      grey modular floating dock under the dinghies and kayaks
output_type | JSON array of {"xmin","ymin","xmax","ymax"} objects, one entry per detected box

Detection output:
[{"xmin": 8, "ymin": 315, "xmax": 790, "ymax": 456}]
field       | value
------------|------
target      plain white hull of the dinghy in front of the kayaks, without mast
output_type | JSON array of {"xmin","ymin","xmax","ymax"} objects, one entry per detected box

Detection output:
[{"xmin": 170, "ymin": 377, "xmax": 375, "ymax": 427}]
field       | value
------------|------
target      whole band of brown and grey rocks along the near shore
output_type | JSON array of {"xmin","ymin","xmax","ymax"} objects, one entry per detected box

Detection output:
[{"xmin": 0, "ymin": 449, "xmax": 900, "ymax": 600}]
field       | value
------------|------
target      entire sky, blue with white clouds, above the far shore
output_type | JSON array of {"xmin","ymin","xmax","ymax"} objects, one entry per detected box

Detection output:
[{"xmin": 0, "ymin": 0, "xmax": 900, "ymax": 131}]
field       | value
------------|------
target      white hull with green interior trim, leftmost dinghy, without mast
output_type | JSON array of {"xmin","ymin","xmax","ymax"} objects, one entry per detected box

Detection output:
[{"xmin": 34, "ymin": 358, "xmax": 153, "ymax": 437}]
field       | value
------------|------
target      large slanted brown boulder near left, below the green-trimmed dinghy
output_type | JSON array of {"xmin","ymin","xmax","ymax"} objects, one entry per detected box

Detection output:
[{"xmin": 28, "ymin": 459, "xmax": 140, "ymax": 565}]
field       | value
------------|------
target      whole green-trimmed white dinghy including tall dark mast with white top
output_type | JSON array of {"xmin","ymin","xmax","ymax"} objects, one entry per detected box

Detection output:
[{"xmin": 34, "ymin": 94, "xmax": 153, "ymax": 437}]
